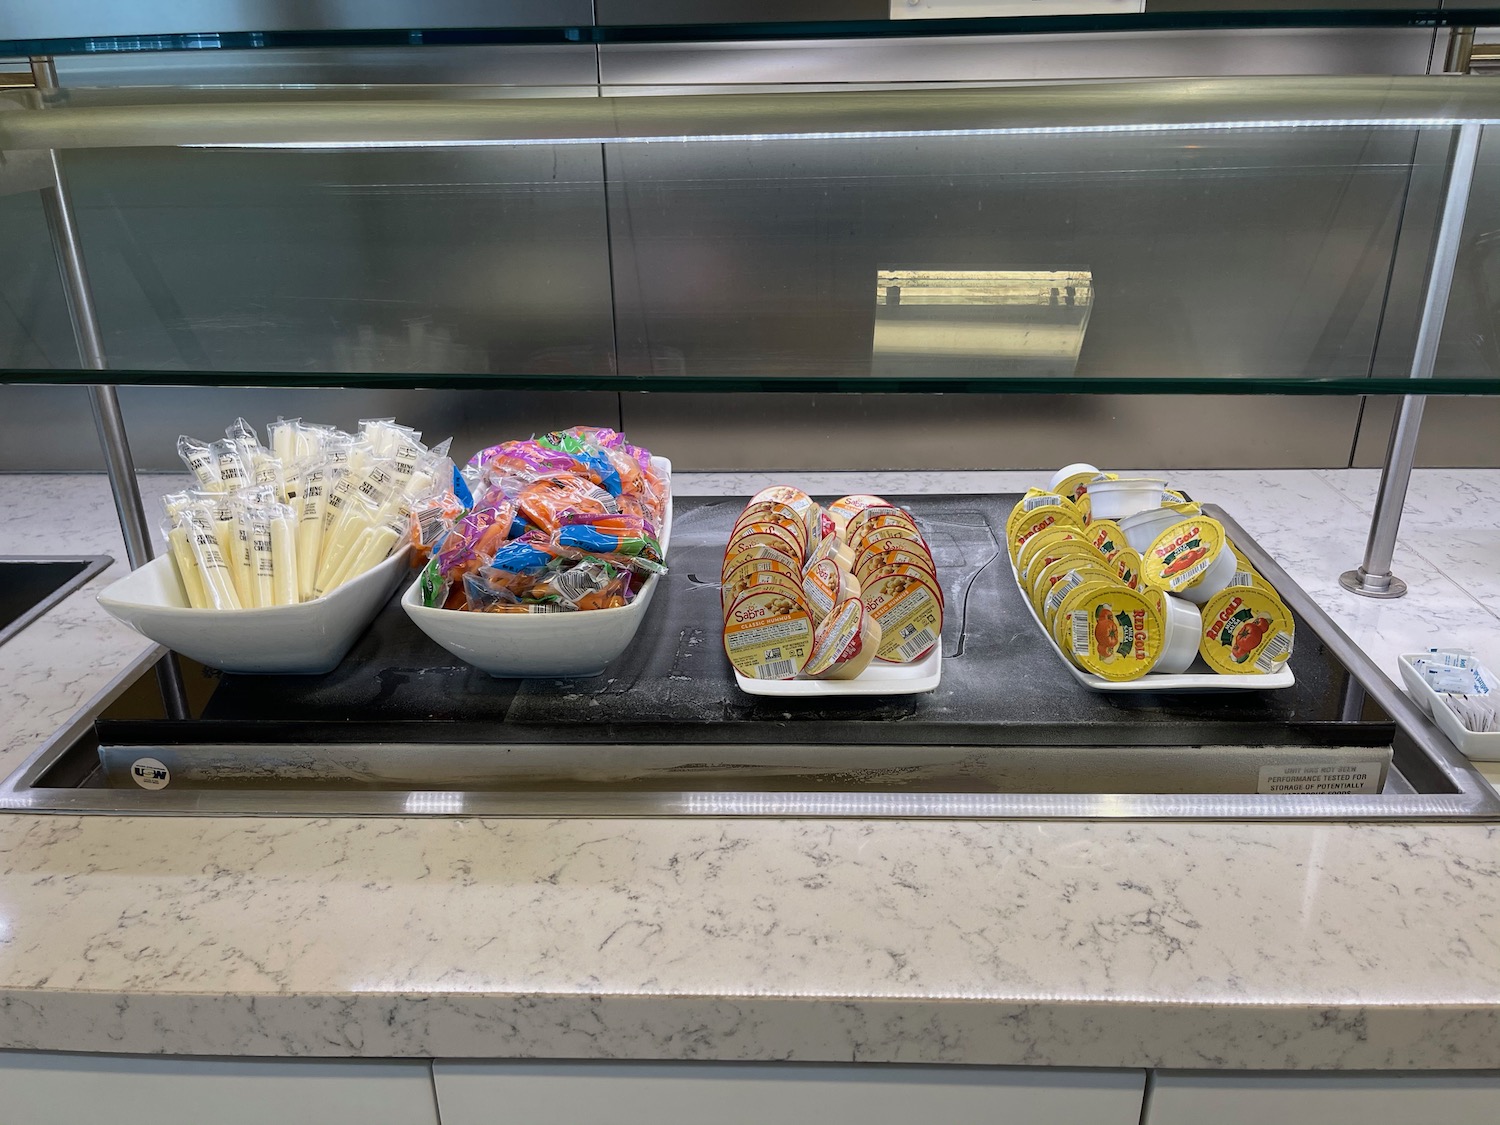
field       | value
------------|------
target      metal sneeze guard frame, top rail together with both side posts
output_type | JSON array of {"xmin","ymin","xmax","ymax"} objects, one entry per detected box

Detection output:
[{"xmin": 0, "ymin": 70, "xmax": 1500, "ymax": 627}]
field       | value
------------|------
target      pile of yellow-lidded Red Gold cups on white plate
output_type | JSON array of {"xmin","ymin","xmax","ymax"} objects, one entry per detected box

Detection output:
[{"xmin": 1005, "ymin": 465, "xmax": 1293, "ymax": 681}]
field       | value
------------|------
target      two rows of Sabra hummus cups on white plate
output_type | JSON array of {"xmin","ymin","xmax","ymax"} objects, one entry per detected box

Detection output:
[{"xmin": 720, "ymin": 485, "xmax": 944, "ymax": 680}]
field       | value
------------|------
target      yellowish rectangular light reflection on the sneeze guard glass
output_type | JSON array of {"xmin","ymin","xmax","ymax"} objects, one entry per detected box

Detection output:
[{"xmin": 870, "ymin": 269, "xmax": 1094, "ymax": 378}]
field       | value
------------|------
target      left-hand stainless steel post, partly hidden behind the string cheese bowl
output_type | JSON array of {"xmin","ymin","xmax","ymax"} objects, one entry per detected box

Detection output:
[{"xmin": 32, "ymin": 59, "xmax": 188, "ymax": 719}]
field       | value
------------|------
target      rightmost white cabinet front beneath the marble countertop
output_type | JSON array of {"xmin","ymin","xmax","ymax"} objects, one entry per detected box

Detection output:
[{"xmin": 1143, "ymin": 1071, "xmax": 1500, "ymax": 1125}]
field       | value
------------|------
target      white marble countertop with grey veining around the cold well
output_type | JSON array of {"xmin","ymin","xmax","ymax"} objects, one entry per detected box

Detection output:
[{"xmin": 0, "ymin": 473, "xmax": 1500, "ymax": 1068}]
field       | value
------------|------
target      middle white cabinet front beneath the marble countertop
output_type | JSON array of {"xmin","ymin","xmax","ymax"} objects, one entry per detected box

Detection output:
[{"xmin": 432, "ymin": 1062, "xmax": 1145, "ymax": 1125}]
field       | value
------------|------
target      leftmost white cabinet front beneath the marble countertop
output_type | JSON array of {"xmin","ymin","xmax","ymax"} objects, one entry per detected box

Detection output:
[{"xmin": 0, "ymin": 1052, "xmax": 438, "ymax": 1125}]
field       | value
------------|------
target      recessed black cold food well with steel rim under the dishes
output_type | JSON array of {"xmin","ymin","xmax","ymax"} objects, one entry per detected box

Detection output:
[{"xmin": 0, "ymin": 507, "xmax": 1500, "ymax": 821}]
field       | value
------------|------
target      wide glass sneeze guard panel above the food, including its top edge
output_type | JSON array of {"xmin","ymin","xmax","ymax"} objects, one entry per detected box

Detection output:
[{"xmin": 0, "ymin": 78, "xmax": 1500, "ymax": 395}]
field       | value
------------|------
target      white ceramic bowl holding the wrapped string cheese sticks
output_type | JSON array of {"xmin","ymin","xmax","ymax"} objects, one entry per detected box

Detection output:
[{"xmin": 99, "ymin": 548, "xmax": 411, "ymax": 675}]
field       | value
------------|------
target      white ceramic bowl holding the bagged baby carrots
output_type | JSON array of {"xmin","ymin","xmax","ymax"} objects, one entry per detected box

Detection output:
[{"xmin": 401, "ymin": 458, "xmax": 672, "ymax": 680}]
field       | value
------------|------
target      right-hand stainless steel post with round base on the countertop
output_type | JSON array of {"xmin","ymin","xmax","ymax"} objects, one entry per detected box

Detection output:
[{"xmin": 1338, "ymin": 125, "xmax": 1484, "ymax": 599}]
